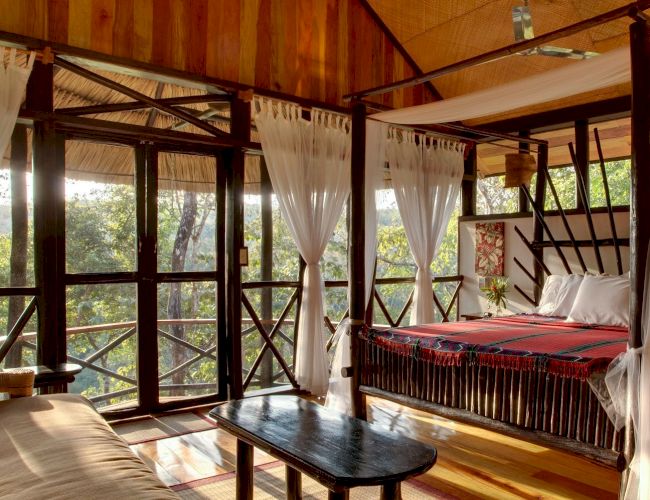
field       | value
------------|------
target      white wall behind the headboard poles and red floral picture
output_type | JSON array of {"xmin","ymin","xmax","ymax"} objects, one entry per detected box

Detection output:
[{"xmin": 458, "ymin": 212, "xmax": 630, "ymax": 314}]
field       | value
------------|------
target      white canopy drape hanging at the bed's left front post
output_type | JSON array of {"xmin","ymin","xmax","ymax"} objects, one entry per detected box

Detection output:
[{"xmin": 325, "ymin": 120, "xmax": 388, "ymax": 415}]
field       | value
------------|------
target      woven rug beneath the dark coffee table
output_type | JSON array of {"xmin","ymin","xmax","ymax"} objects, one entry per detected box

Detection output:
[{"xmin": 172, "ymin": 461, "xmax": 455, "ymax": 500}]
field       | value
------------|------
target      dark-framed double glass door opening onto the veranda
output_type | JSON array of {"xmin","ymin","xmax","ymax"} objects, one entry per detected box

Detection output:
[{"xmin": 65, "ymin": 139, "xmax": 226, "ymax": 413}]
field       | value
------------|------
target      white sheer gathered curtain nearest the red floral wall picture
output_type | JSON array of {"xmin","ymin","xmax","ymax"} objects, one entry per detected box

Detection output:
[{"xmin": 387, "ymin": 127, "xmax": 465, "ymax": 325}]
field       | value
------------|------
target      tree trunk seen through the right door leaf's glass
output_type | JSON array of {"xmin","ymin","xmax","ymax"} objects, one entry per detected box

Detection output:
[{"xmin": 167, "ymin": 191, "xmax": 197, "ymax": 395}]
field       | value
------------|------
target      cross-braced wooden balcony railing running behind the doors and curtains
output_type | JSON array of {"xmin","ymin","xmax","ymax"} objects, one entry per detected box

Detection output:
[{"xmin": 0, "ymin": 276, "xmax": 463, "ymax": 404}]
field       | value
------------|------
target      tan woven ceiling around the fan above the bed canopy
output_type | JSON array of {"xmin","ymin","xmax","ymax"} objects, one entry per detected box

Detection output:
[{"xmin": 369, "ymin": 0, "xmax": 630, "ymax": 124}]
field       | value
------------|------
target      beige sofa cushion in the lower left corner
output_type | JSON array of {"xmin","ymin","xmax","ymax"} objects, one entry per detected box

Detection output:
[{"xmin": 0, "ymin": 394, "xmax": 178, "ymax": 500}]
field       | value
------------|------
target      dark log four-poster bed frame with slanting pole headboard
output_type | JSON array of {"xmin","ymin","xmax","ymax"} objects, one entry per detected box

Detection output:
[{"xmin": 346, "ymin": 2, "xmax": 650, "ymax": 470}]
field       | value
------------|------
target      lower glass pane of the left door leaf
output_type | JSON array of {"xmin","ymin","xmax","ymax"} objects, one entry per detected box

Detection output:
[{"xmin": 66, "ymin": 283, "xmax": 138, "ymax": 408}]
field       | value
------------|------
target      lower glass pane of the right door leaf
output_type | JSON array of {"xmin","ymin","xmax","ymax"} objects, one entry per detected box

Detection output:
[{"xmin": 158, "ymin": 282, "xmax": 218, "ymax": 401}]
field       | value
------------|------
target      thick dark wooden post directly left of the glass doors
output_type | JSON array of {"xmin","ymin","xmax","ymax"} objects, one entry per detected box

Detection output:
[{"xmin": 26, "ymin": 61, "xmax": 66, "ymax": 366}]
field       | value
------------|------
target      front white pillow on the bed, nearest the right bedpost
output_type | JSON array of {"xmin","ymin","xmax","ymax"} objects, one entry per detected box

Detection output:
[{"xmin": 567, "ymin": 276, "xmax": 630, "ymax": 326}]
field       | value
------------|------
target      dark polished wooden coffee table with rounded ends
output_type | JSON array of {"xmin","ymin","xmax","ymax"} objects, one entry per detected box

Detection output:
[{"xmin": 210, "ymin": 395, "xmax": 436, "ymax": 500}]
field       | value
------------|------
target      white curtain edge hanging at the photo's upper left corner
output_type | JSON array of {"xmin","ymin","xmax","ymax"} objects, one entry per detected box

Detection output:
[{"xmin": 0, "ymin": 48, "xmax": 36, "ymax": 157}]
